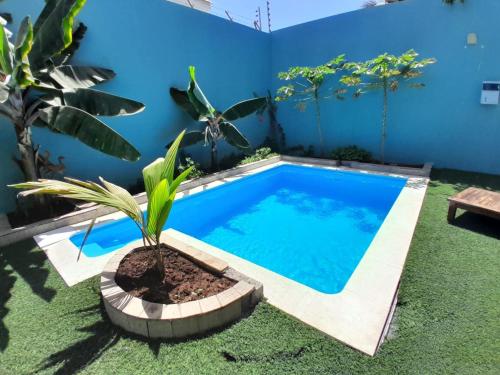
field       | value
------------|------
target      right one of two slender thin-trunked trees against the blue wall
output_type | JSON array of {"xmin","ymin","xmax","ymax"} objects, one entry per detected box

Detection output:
[{"xmin": 340, "ymin": 50, "xmax": 436, "ymax": 163}]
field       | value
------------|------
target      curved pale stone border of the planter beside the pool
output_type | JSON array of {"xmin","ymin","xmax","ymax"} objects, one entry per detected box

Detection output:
[{"xmin": 101, "ymin": 245, "xmax": 262, "ymax": 339}]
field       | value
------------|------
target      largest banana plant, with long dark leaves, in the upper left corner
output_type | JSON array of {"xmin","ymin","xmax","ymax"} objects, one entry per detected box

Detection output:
[{"xmin": 0, "ymin": 0, "xmax": 144, "ymax": 185}]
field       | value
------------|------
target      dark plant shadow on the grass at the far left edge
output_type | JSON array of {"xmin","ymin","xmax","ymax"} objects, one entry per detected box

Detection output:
[{"xmin": 0, "ymin": 240, "xmax": 56, "ymax": 352}]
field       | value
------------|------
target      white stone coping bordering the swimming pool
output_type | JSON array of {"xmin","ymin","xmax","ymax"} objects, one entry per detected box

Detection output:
[{"xmin": 34, "ymin": 160, "xmax": 429, "ymax": 355}]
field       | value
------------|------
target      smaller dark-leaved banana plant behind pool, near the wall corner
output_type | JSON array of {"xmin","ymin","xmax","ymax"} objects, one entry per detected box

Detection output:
[{"xmin": 170, "ymin": 66, "xmax": 267, "ymax": 170}]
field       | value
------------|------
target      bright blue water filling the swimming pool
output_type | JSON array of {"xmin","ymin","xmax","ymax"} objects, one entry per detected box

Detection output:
[{"xmin": 71, "ymin": 165, "xmax": 406, "ymax": 294}]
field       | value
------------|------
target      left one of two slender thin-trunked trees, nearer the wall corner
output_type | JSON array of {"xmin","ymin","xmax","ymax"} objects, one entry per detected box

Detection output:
[{"xmin": 276, "ymin": 55, "xmax": 345, "ymax": 156}]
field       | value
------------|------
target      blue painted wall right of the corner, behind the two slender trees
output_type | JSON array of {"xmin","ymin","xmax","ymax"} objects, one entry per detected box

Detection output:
[{"xmin": 272, "ymin": 0, "xmax": 500, "ymax": 174}]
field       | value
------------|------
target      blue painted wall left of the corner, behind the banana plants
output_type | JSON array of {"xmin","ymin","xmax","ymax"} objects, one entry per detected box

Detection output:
[{"xmin": 0, "ymin": 0, "xmax": 271, "ymax": 212}]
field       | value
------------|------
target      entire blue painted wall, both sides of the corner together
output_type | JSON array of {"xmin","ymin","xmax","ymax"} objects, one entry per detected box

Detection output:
[{"xmin": 0, "ymin": 0, "xmax": 500, "ymax": 212}]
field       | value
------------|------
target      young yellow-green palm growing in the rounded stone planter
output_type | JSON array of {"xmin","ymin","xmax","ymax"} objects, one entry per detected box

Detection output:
[{"xmin": 10, "ymin": 131, "xmax": 192, "ymax": 280}]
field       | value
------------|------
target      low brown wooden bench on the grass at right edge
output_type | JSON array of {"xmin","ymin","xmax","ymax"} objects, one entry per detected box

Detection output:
[{"xmin": 448, "ymin": 188, "xmax": 500, "ymax": 223}]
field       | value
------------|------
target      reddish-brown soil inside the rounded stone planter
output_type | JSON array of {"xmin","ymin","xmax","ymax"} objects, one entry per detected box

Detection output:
[{"xmin": 115, "ymin": 247, "xmax": 235, "ymax": 304}]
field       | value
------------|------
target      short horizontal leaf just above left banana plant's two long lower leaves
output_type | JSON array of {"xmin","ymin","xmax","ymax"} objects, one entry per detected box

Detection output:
[{"xmin": 48, "ymin": 65, "xmax": 116, "ymax": 89}]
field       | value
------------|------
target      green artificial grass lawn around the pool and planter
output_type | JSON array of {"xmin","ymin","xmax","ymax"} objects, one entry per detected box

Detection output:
[{"xmin": 0, "ymin": 170, "xmax": 500, "ymax": 375}]
